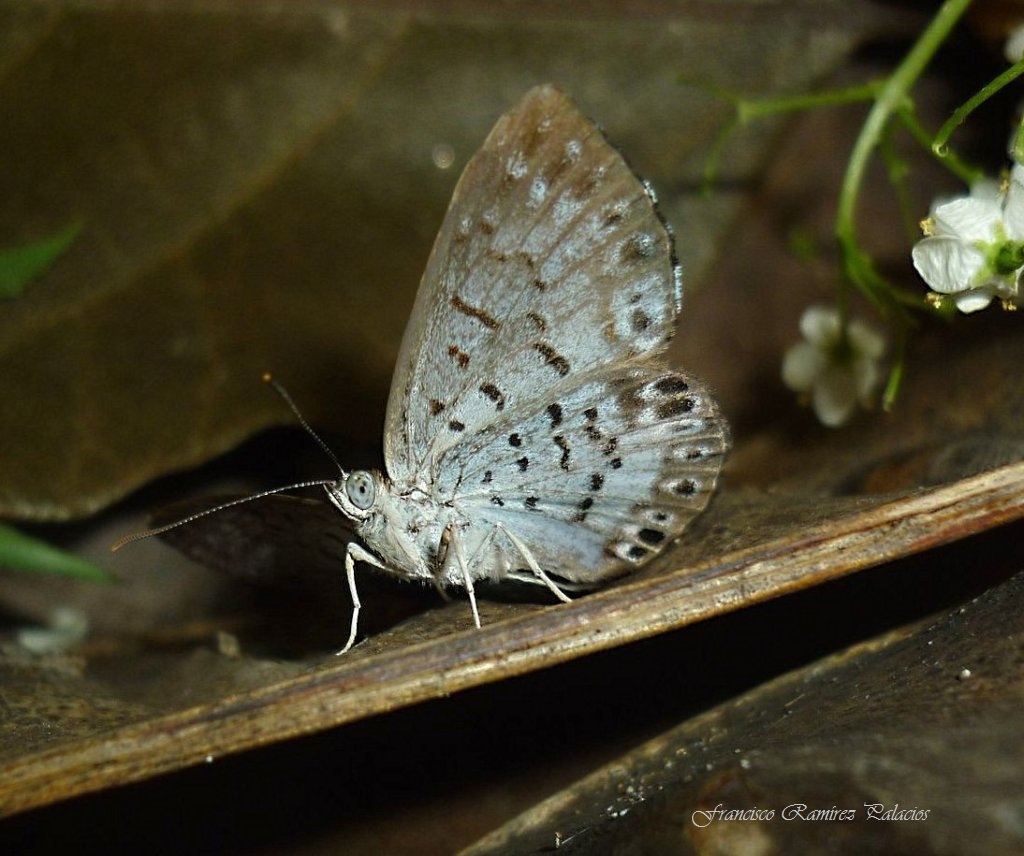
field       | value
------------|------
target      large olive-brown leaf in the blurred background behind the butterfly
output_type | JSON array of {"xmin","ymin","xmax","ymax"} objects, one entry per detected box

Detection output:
[{"xmin": 0, "ymin": 0, "xmax": 913, "ymax": 519}]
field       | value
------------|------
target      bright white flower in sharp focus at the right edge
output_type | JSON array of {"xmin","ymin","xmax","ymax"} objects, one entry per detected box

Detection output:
[{"xmin": 911, "ymin": 164, "xmax": 1024, "ymax": 312}]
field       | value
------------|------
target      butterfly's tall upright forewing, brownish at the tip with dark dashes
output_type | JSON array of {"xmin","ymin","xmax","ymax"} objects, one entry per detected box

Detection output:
[{"xmin": 385, "ymin": 86, "xmax": 679, "ymax": 484}]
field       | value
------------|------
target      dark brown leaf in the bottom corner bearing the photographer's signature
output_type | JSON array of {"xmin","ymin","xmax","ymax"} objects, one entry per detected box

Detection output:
[{"xmin": 464, "ymin": 573, "xmax": 1024, "ymax": 856}]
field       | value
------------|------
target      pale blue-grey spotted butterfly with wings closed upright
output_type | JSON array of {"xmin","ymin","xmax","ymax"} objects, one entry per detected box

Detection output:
[{"xmin": 119, "ymin": 85, "xmax": 728, "ymax": 652}]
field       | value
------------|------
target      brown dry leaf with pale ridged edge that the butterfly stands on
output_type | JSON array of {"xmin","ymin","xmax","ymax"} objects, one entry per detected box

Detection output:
[{"xmin": 0, "ymin": 464, "xmax": 1024, "ymax": 812}]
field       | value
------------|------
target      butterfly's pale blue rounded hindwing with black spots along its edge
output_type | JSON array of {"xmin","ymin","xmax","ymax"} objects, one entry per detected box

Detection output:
[{"xmin": 437, "ymin": 367, "xmax": 726, "ymax": 582}]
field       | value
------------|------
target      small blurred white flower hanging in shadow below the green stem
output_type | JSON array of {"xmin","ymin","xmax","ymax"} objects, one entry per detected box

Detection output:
[{"xmin": 782, "ymin": 306, "xmax": 886, "ymax": 428}]
